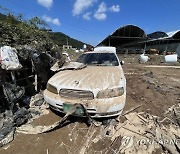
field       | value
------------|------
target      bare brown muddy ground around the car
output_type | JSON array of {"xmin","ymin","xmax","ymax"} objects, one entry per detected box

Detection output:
[{"xmin": 0, "ymin": 54, "xmax": 180, "ymax": 154}]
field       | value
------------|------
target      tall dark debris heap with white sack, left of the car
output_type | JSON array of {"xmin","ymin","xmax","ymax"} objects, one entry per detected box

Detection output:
[{"xmin": 0, "ymin": 46, "xmax": 60, "ymax": 146}]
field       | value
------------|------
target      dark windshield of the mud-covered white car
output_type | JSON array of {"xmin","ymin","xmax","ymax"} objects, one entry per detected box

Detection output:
[{"xmin": 77, "ymin": 53, "xmax": 119, "ymax": 66}]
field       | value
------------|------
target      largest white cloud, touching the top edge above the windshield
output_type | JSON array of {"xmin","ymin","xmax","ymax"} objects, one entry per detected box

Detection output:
[{"xmin": 72, "ymin": 0, "xmax": 97, "ymax": 16}]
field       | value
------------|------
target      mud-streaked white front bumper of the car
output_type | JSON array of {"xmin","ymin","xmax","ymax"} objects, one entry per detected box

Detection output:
[{"xmin": 44, "ymin": 89, "xmax": 126, "ymax": 118}]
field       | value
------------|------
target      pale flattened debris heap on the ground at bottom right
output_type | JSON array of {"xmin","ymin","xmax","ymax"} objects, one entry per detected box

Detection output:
[{"xmin": 111, "ymin": 112, "xmax": 180, "ymax": 154}]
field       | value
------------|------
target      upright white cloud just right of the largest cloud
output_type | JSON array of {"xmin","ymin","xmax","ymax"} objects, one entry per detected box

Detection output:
[{"xmin": 94, "ymin": 2, "xmax": 107, "ymax": 20}]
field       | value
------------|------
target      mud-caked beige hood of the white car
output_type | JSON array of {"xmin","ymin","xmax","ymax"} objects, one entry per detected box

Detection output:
[{"xmin": 48, "ymin": 66, "xmax": 125, "ymax": 95}]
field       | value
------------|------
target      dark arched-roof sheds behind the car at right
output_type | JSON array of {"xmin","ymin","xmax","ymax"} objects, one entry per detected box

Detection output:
[{"xmin": 97, "ymin": 25, "xmax": 180, "ymax": 57}]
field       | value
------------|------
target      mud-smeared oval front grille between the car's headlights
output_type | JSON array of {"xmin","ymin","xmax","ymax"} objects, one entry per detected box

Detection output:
[{"xmin": 59, "ymin": 89, "xmax": 94, "ymax": 100}]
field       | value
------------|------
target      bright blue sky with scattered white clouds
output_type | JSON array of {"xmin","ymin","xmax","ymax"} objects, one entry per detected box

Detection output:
[{"xmin": 0, "ymin": 0, "xmax": 180, "ymax": 45}]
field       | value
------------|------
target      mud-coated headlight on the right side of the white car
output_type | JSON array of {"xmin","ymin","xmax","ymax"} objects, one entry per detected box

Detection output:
[{"xmin": 97, "ymin": 87, "xmax": 124, "ymax": 98}]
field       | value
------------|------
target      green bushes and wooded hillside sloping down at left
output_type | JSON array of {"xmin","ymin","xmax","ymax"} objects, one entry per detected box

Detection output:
[{"xmin": 0, "ymin": 13, "xmax": 90, "ymax": 49}]
